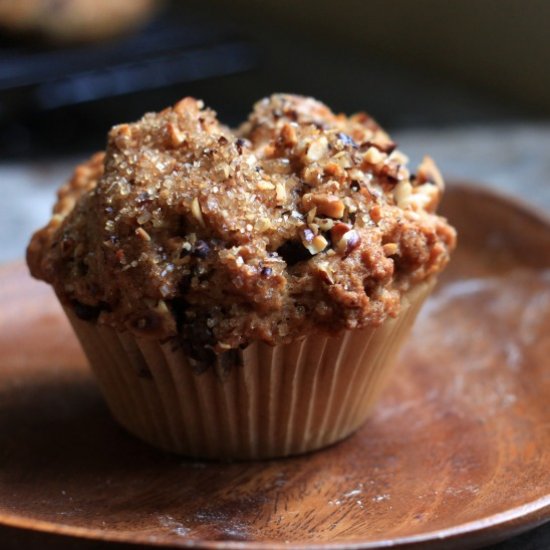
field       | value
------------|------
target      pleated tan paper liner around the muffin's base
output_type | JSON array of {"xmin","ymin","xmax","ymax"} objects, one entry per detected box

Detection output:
[{"xmin": 66, "ymin": 281, "xmax": 434, "ymax": 459}]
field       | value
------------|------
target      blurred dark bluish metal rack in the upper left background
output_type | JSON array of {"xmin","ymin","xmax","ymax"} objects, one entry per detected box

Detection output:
[{"xmin": 0, "ymin": 12, "xmax": 258, "ymax": 119}]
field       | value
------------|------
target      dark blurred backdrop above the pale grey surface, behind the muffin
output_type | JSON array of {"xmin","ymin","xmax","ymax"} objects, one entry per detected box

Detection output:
[{"xmin": 0, "ymin": 0, "xmax": 550, "ymax": 159}]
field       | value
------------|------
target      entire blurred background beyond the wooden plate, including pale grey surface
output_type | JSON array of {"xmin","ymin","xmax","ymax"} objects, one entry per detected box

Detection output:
[{"xmin": 0, "ymin": 0, "xmax": 550, "ymax": 550}]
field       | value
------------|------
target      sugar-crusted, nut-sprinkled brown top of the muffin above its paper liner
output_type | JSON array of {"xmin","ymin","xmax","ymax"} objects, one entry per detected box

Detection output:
[{"xmin": 27, "ymin": 95, "xmax": 455, "ymax": 361}]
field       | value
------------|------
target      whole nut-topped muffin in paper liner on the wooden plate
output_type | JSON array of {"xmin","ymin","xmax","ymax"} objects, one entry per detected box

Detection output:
[{"xmin": 27, "ymin": 95, "xmax": 455, "ymax": 458}]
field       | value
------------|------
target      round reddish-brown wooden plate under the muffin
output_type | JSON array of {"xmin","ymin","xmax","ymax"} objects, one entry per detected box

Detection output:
[{"xmin": 0, "ymin": 186, "xmax": 550, "ymax": 548}]
